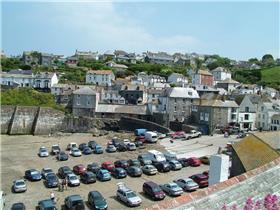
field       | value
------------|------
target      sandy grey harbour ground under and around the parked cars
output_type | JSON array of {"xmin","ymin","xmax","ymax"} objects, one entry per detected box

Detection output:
[{"xmin": 0, "ymin": 133, "xmax": 235, "ymax": 210}]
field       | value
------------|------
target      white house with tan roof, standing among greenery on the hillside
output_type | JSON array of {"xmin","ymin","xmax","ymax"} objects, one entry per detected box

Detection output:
[{"xmin": 86, "ymin": 70, "xmax": 115, "ymax": 86}]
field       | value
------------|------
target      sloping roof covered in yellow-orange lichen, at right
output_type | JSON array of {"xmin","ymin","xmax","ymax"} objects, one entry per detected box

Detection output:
[{"xmin": 232, "ymin": 134, "xmax": 280, "ymax": 171}]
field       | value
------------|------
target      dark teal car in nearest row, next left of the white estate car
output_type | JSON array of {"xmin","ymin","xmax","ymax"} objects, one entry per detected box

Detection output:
[{"xmin": 88, "ymin": 191, "xmax": 108, "ymax": 210}]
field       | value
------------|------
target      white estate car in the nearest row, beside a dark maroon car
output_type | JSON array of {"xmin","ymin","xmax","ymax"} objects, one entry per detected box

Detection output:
[{"xmin": 117, "ymin": 183, "xmax": 142, "ymax": 207}]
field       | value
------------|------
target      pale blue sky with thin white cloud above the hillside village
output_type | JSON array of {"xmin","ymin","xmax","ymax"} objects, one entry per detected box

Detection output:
[{"xmin": 1, "ymin": 0, "xmax": 280, "ymax": 60}]
